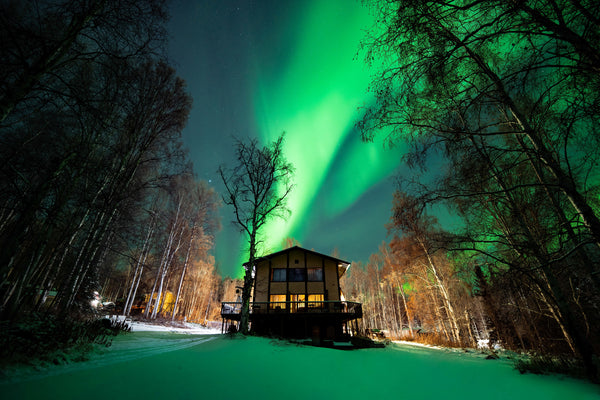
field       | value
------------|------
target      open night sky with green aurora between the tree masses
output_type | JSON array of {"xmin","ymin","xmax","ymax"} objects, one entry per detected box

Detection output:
[{"xmin": 169, "ymin": 0, "xmax": 401, "ymax": 276}]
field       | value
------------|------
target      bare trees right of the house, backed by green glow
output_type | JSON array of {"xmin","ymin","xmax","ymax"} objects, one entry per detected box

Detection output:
[{"xmin": 346, "ymin": 0, "xmax": 600, "ymax": 381}]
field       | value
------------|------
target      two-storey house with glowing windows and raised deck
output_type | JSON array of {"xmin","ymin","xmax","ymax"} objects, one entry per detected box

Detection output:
[{"xmin": 221, "ymin": 246, "xmax": 362, "ymax": 345}]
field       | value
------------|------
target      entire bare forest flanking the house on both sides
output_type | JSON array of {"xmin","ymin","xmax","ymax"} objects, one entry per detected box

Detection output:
[{"xmin": 0, "ymin": 0, "xmax": 600, "ymax": 381}]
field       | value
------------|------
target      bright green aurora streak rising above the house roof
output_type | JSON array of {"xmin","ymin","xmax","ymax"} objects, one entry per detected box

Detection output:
[{"xmin": 246, "ymin": 0, "xmax": 406, "ymax": 268}]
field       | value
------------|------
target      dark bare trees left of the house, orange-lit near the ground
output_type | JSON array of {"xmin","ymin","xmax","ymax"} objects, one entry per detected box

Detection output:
[{"xmin": 0, "ymin": 0, "xmax": 231, "ymax": 355}]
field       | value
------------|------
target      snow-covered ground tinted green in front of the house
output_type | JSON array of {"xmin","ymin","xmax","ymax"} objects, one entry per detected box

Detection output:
[{"xmin": 0, "ymin": 325, "xmax": 600, "ymax": 400}]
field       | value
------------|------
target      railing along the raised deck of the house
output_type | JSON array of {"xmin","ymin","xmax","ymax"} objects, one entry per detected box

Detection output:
[{"xmin": 221, "ymin": 301, "xmax": 362, "ymax": 317}]
